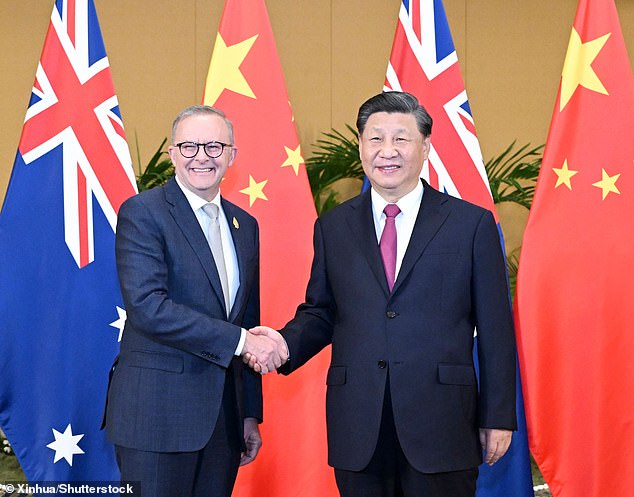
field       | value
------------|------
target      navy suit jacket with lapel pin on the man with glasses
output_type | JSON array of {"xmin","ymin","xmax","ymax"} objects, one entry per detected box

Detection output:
[{"xmin": 106, "ymin": 180, "xmax": 262, "ymax": 452}]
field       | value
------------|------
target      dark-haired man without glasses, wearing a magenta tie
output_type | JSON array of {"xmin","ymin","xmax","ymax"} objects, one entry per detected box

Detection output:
[{"xmin": 247, "ymin": 92, "xmax": 516, "ymax": 497}]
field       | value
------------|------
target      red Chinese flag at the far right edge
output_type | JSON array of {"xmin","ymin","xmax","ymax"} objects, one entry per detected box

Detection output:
[{"xmin": 516, "ymin": 0, "xmax": 634, "ymax": 497}]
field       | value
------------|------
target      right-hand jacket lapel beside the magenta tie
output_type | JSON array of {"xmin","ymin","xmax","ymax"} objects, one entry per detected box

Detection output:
[{"xmin": 392, "ymin": 181, "xmax": 449, "ymax": 293}]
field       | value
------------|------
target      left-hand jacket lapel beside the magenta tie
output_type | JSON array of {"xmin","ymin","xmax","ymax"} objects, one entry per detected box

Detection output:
[{"xmin": 348, "ymin": 190, "xmax": 390, "ymax": 295}]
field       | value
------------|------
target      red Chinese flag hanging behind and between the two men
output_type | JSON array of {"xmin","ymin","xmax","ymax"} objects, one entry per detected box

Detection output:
[{"xmin": 203, "ymin": 0, "xmax": 337, "ymax": 497}]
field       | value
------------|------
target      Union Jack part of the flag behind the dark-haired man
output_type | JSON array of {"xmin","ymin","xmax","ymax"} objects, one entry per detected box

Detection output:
[{"xmin": 384, "ymin": 0, "xmax": 495, "ymax": 212}]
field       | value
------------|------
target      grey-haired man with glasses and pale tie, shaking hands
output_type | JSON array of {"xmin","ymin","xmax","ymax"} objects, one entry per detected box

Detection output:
[{"xmin": 106, "ymin": 106, "xmax": 286, "ymax": 497}]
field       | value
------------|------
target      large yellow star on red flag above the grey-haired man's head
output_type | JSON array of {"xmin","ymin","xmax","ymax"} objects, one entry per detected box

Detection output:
[{"xmin": 204, "ymin": 33, "xmax": 258, "ymax": 106}]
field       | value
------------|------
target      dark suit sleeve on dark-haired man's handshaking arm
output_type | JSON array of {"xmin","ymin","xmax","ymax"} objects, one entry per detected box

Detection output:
[{"xmin": 280, "ymin": 219, "xmax": 336, "ymax": 374}]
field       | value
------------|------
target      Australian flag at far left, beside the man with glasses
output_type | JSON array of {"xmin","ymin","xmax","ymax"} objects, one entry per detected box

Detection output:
[{"xmin": 0, "ymin": 0, "xmax": 136, "ymax": 482}]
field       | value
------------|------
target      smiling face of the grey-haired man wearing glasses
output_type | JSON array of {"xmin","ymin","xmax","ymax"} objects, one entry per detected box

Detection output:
[{"xmin": 168, "ymin": 114, "xmax": 237, "ymax": 201}]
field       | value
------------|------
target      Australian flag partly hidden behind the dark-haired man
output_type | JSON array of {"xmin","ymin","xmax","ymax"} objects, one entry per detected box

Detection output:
[{"xmin": 384, "ymin": 0, "xmax": 533, "ymax": 497}]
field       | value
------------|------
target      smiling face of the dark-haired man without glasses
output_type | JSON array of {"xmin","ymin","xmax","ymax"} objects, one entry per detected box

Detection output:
[{"xmin": 359, "ymin": 112, "xmax": 430, "ymax": 202}]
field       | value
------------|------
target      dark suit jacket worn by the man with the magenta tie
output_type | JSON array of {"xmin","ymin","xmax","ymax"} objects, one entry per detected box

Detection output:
[{"xmin": 282, "ymin": 183, "xmax": 516, "ymax": 472}]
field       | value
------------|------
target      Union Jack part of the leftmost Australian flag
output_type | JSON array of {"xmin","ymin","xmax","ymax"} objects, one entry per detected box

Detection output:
[{"xmin": 19, "ymin": 0, "xmax": 136, "ymax": 267}]
